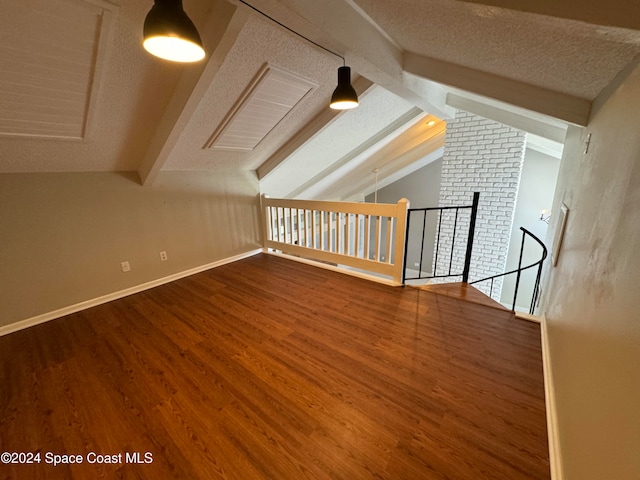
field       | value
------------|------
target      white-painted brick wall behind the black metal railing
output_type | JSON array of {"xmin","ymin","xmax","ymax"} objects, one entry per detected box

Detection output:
[{"xmin": 437, "ymin": 111, "xmax": 526, "ymax": 299}]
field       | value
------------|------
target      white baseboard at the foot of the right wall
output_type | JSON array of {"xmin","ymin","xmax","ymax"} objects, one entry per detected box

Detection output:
[{"xmin": 540, "ymin": 315, "xmax": 564, "ymax": 480}]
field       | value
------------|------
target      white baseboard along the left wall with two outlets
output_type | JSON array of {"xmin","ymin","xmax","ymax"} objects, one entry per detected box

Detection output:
[{"xmin": 0, "ymin": 249, "xmax": 262, "ymax": 337}]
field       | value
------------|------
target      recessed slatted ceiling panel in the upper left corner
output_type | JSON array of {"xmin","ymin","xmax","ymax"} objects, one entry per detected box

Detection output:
[{"xmin": 0, "ymin": 0, "xmax": 114, "ymax": 139}]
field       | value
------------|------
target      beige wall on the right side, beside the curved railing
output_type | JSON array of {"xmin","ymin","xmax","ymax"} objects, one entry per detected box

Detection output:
[{"xmin": 544, "ymin": 68, "xmax": 640, "ymax": 480}]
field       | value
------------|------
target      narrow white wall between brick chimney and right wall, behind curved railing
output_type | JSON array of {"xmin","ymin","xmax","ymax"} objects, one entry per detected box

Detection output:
[{"xmin": 500, "ymin": 148, "xmax": 560, "ymax": 312}]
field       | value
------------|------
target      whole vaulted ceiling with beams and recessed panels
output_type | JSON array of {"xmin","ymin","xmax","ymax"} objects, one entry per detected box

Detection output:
[{"xmin": 0, "ymin": 0, "xmax": 640, "ymax": 198}]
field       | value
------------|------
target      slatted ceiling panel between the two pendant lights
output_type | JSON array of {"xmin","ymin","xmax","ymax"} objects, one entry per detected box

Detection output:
[{"xmin": 205, "ymin": 65, "xmax": 318, "ymax": 151}]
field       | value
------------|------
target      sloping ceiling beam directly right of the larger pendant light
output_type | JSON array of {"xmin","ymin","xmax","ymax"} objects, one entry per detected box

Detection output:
[{"xmin": 138, "ymin": 0, "xmax": 249, "ymax": 185}]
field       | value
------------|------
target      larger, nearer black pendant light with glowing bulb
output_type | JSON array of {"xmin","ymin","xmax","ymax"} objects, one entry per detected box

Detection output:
[{"xmin": 142, "ymin": 0, "xmax": 204, "ymax": 62}]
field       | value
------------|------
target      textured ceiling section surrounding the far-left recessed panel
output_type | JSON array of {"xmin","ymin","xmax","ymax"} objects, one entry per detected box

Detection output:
[{"xmin": 0, "ymin": 0, "xmax": 190, "ymax": 172}]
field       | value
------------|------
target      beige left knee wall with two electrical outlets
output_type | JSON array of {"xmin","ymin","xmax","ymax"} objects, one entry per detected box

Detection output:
[{"xmin": 0, "ymin": 172, "xmax": 260, "ymax": 327}]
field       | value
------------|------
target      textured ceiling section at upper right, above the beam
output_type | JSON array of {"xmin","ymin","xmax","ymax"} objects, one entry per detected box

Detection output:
[{"xmin": 356, "ymin": 0, "xmax": 640, "ymax": 99}]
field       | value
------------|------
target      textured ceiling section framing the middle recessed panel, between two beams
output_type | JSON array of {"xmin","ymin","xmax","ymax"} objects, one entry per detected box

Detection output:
[{"xmin": 165, "ymin": 15, "xmax": 340, "ymax": 170}]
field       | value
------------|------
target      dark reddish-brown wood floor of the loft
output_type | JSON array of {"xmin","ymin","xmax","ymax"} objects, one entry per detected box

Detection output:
[{"xmin": 0, "ymin": 255, "xmax": 550, "ymax": 480}]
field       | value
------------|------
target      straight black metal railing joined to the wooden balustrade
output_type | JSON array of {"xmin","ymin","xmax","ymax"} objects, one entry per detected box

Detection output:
[{"xmin": 402, "ymin": 192, "xmax": 480, "ymax": 284}]
